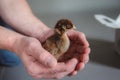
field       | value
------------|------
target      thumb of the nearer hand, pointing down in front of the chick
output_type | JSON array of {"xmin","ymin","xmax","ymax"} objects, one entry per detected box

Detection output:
[{"xmin": 36, "ymin": 46, "xmax": 57, "ymax": 67}]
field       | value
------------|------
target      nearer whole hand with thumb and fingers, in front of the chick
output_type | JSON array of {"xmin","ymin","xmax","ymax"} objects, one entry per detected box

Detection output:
[{"xmin": 14, "ymin": 37, "xmax": 77, "ymax": 79}]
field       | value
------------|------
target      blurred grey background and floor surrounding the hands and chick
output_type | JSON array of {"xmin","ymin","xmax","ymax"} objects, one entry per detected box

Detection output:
[{"xmin": 0, "ymin": 0, "xmax": 120, "ymax": 80}]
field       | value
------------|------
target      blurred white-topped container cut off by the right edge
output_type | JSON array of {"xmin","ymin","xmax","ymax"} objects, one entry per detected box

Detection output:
[{"xmin": 95, "ymin": 14, "xmax": 120, "ymax": 54}]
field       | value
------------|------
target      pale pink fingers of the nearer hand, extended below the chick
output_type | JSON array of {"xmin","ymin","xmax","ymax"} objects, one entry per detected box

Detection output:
[{"xmin": 37, "ymin": 59, "xmax": 77, "ymax": 79}]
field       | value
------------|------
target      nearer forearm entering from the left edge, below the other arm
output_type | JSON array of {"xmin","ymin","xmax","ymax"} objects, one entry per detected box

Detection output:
[{"xmin": 0, "ymin": 26, "xmax": 24, "ymax": 51}]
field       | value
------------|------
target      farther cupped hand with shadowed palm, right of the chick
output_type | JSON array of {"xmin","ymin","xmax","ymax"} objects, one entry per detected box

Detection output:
[{"xmin": 60, "ymin": 30, "xmax": 90, "ymax": 75}]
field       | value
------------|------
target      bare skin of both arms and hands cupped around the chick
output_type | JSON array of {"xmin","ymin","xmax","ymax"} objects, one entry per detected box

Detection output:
[{"xmin": 0, "ymin": 0, "xmax": 90, "ymax": 79}]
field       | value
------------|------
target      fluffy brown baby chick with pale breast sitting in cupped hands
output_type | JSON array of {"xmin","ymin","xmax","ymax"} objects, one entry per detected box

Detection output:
[{"xmin": 43, "ymin": 19, "xmax": 75, "ymax": 60}]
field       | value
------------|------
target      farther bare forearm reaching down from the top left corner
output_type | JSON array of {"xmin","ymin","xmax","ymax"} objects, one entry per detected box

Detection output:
[{"xmin": 0, "ymin": 0, "xmax": 49, "ymax": 38}]
